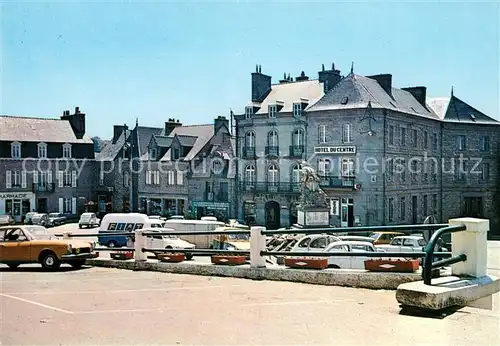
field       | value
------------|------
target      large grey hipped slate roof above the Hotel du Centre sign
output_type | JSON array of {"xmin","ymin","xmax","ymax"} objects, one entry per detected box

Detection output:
[{"xmin": 306, "ymin": 73, "xmax": 439, "ymax": 119}]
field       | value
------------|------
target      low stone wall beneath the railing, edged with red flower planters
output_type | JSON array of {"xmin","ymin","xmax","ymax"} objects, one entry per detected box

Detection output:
[{"xmin": 87, "ymin": 258, "xmax": 430, "ymax": 290}]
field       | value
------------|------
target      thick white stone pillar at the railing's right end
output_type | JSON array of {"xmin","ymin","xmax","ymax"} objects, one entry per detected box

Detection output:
[{"xmin": 448, "ymin": 217, "xmax": 490, "ymax": 277}]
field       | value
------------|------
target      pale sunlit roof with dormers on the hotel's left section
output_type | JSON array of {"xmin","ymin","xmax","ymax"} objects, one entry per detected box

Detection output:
[{"xmin": 248, "ymin": 80, "xmax": 324, "ymax": 114}]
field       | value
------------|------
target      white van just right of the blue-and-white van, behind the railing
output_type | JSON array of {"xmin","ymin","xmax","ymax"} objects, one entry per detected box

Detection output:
[{"xmin": 163, "ymin": 219, "xmax": 225, "ymax": 249}]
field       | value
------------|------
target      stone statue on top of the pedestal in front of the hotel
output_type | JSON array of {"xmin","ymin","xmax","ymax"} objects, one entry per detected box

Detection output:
[{"xmin": 299, "ymin": 161, "xmax": 330, "ymax": 210}]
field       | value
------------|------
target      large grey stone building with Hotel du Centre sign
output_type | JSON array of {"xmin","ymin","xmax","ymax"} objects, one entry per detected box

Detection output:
[{"xmin": 235, "ymin": 67, "xmax": 500, "ymax": 235}]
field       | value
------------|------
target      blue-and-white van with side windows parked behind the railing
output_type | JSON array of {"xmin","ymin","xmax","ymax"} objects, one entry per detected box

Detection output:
[{"xmin": 98, "ymin": 213, "xmax": 163, "ymax": 247}]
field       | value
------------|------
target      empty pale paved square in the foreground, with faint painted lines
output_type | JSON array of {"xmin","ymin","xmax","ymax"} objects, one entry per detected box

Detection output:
[{"xmin": 0, "ymin": 266, "xmax": 500, "ymax": 345}]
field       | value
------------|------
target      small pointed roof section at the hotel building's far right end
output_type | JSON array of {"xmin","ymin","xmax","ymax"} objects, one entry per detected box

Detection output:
[{"xmin": 427, "ymin": 95, "xmax": 500, "ymax": 125}]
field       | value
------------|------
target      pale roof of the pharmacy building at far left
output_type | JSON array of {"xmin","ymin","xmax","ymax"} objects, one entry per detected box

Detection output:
[{"xmin": 0, "ymin": 115, "xmax": 94, "ymax": 144}]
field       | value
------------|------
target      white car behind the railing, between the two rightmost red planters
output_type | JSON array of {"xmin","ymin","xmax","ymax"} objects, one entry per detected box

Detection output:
[{"xmin": 325, "ymin": 241, "xmax": 383, "ymax": 269}]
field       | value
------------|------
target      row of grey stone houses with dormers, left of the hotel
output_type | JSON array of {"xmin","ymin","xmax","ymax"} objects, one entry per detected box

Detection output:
[{"xmin": 97, "ymin": 117, "xmax": 235, "ymax": 219}]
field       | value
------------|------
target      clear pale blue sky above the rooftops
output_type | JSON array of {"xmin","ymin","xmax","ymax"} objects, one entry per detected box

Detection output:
[{"xmin": 0, "ymin": 1, "xmax": 500, "ymax": 138}]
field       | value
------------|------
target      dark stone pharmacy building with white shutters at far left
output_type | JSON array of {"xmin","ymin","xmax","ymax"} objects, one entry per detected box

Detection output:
[{"xmin": 0, "ymin": 107, "xmax": 96, "ymax": 222}]
